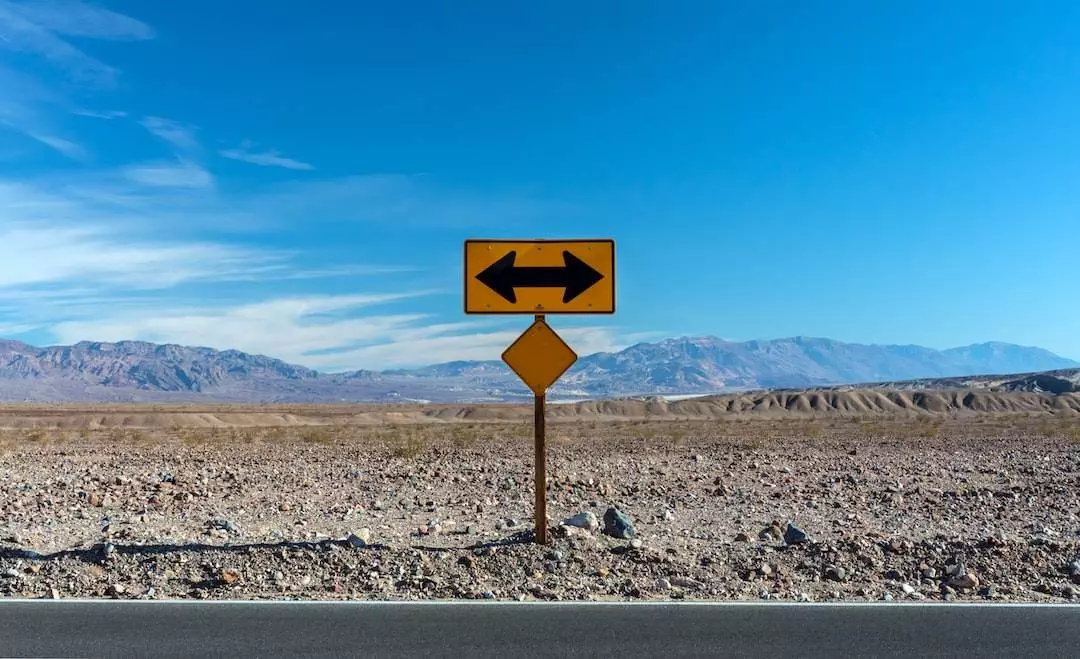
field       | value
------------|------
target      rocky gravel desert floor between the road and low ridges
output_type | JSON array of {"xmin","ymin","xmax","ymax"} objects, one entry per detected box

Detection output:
[{"xmin": 0, "ymin": 407, "xmax": 1080, "ymax": 603}]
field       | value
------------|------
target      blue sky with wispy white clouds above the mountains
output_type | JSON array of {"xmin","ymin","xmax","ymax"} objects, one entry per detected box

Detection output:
[{"xmin": 0, "ymin": 0, "xmax": 1080, "ymax": 371}]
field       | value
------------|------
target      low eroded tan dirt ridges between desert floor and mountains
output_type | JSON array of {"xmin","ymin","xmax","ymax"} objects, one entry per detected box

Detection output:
[{"xmin": 0, "ymin": 389, "xmax": 1080, "ymax": 430}]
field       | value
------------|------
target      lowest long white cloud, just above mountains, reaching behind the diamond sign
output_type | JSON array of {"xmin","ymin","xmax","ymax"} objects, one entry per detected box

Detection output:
[{"xmin": 39, "ymin": 292, "xmax": 630, "ymax": 372}]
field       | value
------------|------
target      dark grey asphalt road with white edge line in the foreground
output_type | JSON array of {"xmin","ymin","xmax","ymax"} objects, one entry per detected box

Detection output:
[{"xmin": 0, "ymin": 601, "xmax": 1080, "ymax": 659}]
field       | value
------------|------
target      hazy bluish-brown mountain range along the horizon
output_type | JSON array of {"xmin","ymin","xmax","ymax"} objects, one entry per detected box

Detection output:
[{"xmin": 0, "ymin": 337, "xmax": 1080, "ymax": 403}]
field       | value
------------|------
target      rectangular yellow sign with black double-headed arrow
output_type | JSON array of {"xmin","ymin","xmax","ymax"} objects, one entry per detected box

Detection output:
[{"xmin": 464, "ymin": 239, "xmax": 615, "ymax": 314}]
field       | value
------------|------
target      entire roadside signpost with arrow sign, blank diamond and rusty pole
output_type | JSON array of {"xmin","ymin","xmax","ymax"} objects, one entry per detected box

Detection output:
[{"xmin": 464, "ymin": 240, "xmax": 615, "ymax": 544}]
